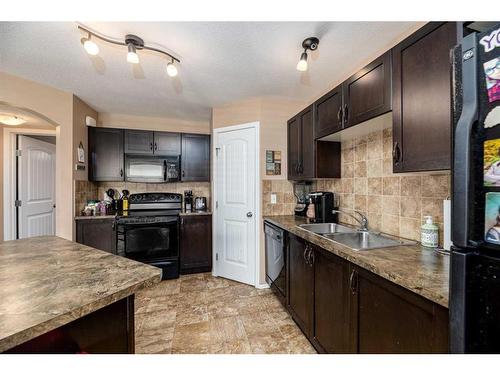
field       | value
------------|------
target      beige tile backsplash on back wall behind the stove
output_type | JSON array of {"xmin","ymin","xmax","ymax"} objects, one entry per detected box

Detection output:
[{"xmin": 75, "ymin": 181, "xmax": 212, "ymax": 215}]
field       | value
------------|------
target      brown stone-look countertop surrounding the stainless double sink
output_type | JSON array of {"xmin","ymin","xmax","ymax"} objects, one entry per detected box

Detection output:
[{"xmin": 264, "ymin": 215, "xmax": 450, "ymax": 307}]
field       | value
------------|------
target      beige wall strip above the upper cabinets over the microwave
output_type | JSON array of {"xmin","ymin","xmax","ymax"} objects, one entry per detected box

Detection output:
[{"xmin": 97, "ymin": 112, "xmax": 210, "ymax": 134}]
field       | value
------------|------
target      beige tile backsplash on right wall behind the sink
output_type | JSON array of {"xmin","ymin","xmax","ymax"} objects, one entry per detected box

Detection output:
[{"xmin": 262, "ymin": 129, "xmax": 450, "ymax": 247}]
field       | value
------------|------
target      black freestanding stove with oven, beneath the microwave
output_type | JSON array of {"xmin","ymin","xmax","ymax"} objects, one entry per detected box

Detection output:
[{"xmin": 116, "ymin": 193, "xmax": 182, "ymax": 279}]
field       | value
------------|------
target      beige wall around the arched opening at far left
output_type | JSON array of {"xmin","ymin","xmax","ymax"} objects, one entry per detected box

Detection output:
[{"xmin": 0, "ymin": 72, "xmax": 73, "ymax": 239}]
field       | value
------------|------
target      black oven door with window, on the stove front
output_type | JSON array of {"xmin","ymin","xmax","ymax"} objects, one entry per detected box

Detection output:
[{"xmin": 123, "ymin": 219, "xmax": 179, "ymax": 262}]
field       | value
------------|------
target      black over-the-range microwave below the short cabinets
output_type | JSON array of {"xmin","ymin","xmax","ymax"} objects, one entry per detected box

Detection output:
[{"xmin": 125, "ymin": 155, "xmax": 180, "ymax": 183}]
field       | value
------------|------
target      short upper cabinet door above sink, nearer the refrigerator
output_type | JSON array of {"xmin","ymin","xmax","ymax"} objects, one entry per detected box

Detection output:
[{"xmin": 343, "ymin": 51, "xmax": 392, "ymax": 127}]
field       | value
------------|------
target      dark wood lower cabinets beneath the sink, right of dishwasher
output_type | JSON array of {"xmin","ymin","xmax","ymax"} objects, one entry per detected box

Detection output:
[{"xmin": 287, "ymin": 233, "xmax": 449, "ymax": 353}]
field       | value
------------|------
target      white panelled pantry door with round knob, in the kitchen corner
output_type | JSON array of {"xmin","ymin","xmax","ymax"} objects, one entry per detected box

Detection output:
[{"xmin": 215, "ymin": 125, "xmax": 259, "ymax": 285}]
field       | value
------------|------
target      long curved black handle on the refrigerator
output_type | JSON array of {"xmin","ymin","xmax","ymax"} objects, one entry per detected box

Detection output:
[{"xmin": 452, "ymin": 33, "xmax": 478, "ymax": 247}]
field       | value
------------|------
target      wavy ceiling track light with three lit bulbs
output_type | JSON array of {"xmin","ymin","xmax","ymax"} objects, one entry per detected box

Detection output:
[{"xmin": 78, "ymin": 25, "xmax": 181, "ymax": 77}]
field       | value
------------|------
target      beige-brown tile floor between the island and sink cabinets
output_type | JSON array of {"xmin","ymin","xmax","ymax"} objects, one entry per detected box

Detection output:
[{"xmin": 135, "ymin": 273, "xmax": 316, "ymax": 354}]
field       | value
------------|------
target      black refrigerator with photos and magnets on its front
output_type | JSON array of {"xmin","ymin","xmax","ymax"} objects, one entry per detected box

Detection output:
[{"xmin": 449, "ymin": 24, "xmax": 500, "ymax": 353}]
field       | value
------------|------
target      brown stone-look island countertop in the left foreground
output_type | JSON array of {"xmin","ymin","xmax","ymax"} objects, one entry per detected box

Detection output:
[{"xmin": 0, "ymin": 236, "xmax": 161, "ymax": 352}]
